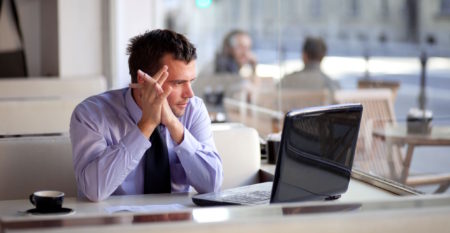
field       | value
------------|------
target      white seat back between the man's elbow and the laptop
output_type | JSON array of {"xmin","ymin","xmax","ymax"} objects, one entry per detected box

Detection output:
[{"xmin": 213, "ymin": 124, "xmax": 261, "ymax": 189}]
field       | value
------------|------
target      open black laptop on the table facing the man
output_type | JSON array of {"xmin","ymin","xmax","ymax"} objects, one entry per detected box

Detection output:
[{"xmin": 192, "ymin": 104, "xmax": 363, "ymax": 206}]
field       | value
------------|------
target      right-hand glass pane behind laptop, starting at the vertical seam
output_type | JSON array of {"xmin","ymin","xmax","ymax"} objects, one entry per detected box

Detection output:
[{"xmin": 278, "ymin": 0, "xmax": 450, "ymax": 195}]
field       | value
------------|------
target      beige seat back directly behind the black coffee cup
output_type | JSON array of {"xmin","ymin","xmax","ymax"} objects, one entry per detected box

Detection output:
[{"xmin": 0, "ymin": 135, "xmax": 77, "ymax": 200}]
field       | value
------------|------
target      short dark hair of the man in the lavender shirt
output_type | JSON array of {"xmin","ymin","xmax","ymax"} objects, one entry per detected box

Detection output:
[{"xmin": 127, "ymin": 29, "xmax": 197, "ymax": 83}]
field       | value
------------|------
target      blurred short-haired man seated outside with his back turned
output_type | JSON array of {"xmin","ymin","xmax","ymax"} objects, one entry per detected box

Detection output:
[{"xmin": 281, "ymin": 37, "xmax": 339, "ymax": 101}]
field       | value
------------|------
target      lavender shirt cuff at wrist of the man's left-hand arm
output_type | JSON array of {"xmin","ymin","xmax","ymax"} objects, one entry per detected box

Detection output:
[{"xmin": 122, "ymin": 126, "xmax": 151, "ymax": 160}]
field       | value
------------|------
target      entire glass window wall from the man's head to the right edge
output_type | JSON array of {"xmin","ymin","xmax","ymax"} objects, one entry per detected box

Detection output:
[{"xmin": 166, "ymin": 0, "xmax": 450, "ymax": 195}]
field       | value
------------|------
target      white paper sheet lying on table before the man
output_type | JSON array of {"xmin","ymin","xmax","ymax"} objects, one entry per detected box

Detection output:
[{"xmin": 105, "ymin": 204, "xmax": 186, "ymax": 214}]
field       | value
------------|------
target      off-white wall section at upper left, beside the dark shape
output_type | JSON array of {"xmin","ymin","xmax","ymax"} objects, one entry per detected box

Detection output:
[{"xmin": 58, "ymin": 0, "xmax": 103, "ymax": 78}]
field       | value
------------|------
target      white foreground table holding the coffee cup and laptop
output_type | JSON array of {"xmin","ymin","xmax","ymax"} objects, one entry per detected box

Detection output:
[{"xmin": 0, "ymin": 161, "xmax": 422, "ymax": 232}]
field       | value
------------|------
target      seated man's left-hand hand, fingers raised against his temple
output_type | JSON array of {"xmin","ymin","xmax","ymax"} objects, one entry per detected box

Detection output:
[{"xmin": 130, "ymin": 66, "xmax": 172, "ymax": 138}]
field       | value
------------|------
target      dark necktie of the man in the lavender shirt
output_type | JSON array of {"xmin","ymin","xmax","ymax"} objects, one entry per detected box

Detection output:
[{"xmin": 144, "ymin": 127, "xmax": 171, "ymax": 194}]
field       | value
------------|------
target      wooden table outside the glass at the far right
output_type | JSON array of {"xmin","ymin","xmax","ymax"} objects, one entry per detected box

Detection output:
[{"xmin": 373, "ymin": 125, "xmax": 450, "ymax": 192}]
